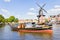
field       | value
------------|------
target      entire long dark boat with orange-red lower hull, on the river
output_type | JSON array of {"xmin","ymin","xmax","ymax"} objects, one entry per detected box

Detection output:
[{"xmin": 10, "ymin": 23, "xmax": 52, "ymax": 33}]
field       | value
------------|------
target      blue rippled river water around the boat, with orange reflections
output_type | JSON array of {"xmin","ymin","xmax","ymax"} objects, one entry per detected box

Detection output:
[{"xmin": 0, "ymin": 25, "xmax": 60, "ymax": 40}]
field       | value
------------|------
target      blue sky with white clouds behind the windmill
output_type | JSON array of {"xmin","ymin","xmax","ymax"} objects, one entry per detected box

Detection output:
[{"xmin": 0, "ymin": 0, "xmax": 60, "ymax": 19}]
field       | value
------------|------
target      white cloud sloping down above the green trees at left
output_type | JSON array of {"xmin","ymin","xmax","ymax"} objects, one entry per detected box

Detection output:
[{"xmin": 0, "ymin": 8, "xmax": 21, "ymax": 19}]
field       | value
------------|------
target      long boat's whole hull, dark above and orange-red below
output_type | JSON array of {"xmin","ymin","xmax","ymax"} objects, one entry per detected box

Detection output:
[{"xmin": 12, "ymin": 27, "xmax": 52, "ymax": 33}]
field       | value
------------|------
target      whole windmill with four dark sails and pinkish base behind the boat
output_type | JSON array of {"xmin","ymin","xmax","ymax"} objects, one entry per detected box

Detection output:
[{"xmin": 37, "ymin": 4, "xmax": 47, "ymax": 24}]
